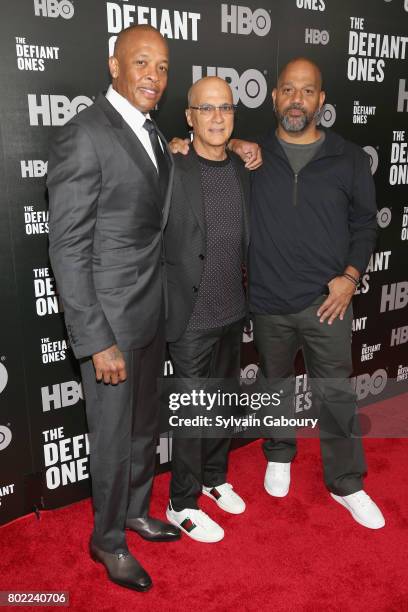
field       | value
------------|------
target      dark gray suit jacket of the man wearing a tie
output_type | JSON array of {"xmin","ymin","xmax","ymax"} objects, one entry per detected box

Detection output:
[{"xmin": 47, "ymin": 94, "xmax": 174, "ymax": 358}]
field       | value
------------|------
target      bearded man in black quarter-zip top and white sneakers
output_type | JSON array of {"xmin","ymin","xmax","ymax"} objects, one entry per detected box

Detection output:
[{"xmin": 232, "ymin": 58, "xmax": 384, "ymax": 529}]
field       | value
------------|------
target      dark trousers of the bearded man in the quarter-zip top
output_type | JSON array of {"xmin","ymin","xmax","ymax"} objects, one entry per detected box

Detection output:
[{"xmin": 254, "ymin": 296, "xmax": 366, "ymax": 495}]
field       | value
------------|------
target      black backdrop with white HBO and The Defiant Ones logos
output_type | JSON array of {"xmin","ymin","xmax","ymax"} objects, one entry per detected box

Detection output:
[{"xmin": 0, "ymin": 0, "xmax": 408, "ymax": 524}]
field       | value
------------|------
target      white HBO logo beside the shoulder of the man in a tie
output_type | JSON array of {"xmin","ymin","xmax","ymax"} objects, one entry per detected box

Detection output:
[{"xmin": 27, "ymin": 94, "xmax": 93, "ymax": 126}]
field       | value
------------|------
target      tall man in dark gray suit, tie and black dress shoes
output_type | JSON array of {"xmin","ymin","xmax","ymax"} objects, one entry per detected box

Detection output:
[{"xmin": 48, "ymin": 26, "xmax": 180, "ymax": 591}]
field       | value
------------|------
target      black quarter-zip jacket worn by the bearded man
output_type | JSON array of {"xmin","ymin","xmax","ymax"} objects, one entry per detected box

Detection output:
[{"xmin": 249, "ymin": 130, "xmax": 377, "ymax": 314}]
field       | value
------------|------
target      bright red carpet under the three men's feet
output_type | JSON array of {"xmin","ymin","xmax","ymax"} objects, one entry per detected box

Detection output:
[{"xmin": 0, "ymin": 439, "xmax": 408, "ymax": 612}]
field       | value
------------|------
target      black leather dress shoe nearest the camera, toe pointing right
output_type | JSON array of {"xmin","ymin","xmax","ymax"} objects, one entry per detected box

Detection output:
[{"xmin": 89, "ymin": 542, "xmax": 153, "ymax": 591}]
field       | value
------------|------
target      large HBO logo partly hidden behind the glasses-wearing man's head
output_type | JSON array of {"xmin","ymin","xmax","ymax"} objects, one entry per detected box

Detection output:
[{"xmin": 193, "ymin": 66, "xmax": 268, "ymax": 108}]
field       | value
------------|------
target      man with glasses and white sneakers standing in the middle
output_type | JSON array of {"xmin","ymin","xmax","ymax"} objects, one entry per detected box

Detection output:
[{"xmin": 165, "ymin": 77, "xmax": 249, "ymax": 542}]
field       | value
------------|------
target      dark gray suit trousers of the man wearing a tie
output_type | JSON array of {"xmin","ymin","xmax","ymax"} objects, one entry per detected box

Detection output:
[{"xmin": 81, "ymin": 320, "xmax": 165, "ymax": 552}]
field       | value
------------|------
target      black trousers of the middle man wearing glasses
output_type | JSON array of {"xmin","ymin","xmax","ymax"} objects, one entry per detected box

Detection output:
[{"xmin": 169, "ymin": 320, "xmax": 243, "ymax": 512}]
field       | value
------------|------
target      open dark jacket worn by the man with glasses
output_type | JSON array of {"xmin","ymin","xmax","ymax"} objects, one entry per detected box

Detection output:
[{"xmin": 164, "ymin": 147, "xmax": 250, "ymax": 342}]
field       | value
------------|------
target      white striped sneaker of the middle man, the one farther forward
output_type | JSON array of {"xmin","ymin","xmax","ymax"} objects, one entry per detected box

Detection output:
[{"xmin": 166, "ymin": 503, "xmax": 224, "ymax": 543}]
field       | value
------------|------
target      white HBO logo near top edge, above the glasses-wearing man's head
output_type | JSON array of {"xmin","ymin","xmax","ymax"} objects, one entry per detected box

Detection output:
[{"xmin": 221, "ymin": 4, "xmax": 271, "ymax": 36}]
